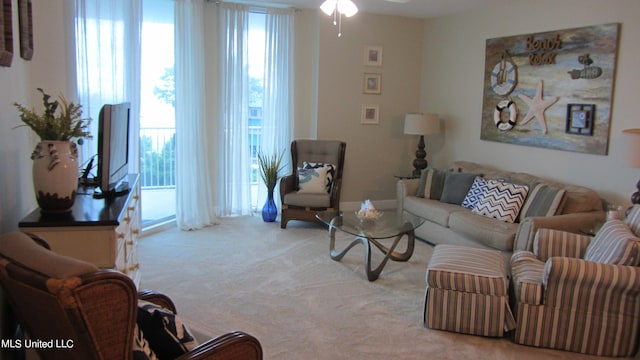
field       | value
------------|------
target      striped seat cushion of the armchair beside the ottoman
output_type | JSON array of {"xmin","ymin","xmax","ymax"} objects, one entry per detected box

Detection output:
[{"xmin": 511, "ymin": 251, "xmax": 544, "ymax": 305}]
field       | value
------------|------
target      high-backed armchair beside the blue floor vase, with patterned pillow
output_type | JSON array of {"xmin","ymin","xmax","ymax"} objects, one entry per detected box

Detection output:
[{"xmin": 280, "ymin": 140, "xmax": 346, "ymax": 229}]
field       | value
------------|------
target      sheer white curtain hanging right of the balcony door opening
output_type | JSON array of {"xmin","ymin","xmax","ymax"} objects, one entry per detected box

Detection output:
[{"xmin": 175, "ymin": 0, "xmax": 217, "ymax": 230}]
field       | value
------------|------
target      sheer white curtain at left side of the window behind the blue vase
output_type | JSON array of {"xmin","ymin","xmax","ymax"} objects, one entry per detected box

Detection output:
[{"xmin": 216, "ymin": 3, "xmax": 251, "ymax": 216}]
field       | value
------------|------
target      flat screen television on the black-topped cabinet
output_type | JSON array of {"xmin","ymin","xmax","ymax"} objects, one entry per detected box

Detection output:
[{"xmin": 94, "ymin": 102, "xmax": 131, "ymax": 198}]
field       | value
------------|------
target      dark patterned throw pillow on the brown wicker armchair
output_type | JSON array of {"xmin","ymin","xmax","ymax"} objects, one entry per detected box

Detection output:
[{"xmin": 134, "ymin": 300, "xmax": 198, "ymax": 359}]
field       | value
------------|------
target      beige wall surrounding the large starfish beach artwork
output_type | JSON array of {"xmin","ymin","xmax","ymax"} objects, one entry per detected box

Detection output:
[{"xmin": 421, "ymin": 0, "xmax": 640, "ymax": 207}]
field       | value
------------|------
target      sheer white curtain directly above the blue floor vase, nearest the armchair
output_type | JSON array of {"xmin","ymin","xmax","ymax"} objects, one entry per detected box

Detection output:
[{"xmin": 258, "ymin": 8, "xmax": 294, "ymax": 209}]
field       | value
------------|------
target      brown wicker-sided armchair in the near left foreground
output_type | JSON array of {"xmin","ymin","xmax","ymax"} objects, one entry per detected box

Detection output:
[{"xmin": 0, "ymin": 232, "xmax": 262, "ymax": 360}]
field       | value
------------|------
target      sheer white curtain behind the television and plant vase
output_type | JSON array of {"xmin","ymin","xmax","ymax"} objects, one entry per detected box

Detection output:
[{"xmin": 75, "ymin": 0, "xmax": 142, "ymax": 172}]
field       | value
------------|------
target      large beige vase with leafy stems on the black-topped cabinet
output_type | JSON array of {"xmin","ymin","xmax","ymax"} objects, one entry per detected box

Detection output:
[{"xmin": 13, "ymin": 88, "xmax": 91, "ymax": 213}]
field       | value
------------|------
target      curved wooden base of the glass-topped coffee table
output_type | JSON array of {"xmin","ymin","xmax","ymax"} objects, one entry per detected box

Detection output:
[{"xmin": 329, "ymin": 226, "xmax": 415, "ymax": 281}]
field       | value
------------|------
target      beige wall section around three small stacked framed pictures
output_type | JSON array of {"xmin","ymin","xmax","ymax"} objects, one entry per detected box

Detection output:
[{"xmin": 317, "ymin": 12, "xmax": 424, "ymax": 204}]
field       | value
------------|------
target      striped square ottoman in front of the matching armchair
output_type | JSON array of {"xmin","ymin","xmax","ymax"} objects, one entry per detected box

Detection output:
[{"xmin": 424, "ymin": 245, "xmax": 515, "ymax": 337}]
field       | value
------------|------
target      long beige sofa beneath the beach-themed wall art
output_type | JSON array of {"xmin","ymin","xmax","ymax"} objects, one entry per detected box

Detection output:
[{"xmin": 397, "ymin": 161, "xmax": 605, "ymax": 258}]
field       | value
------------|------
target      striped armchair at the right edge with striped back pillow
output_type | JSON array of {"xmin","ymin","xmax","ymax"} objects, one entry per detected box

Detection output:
[{"xmin": 511, "ymin": 212, "xmax": 640, "ymax": 356}]
